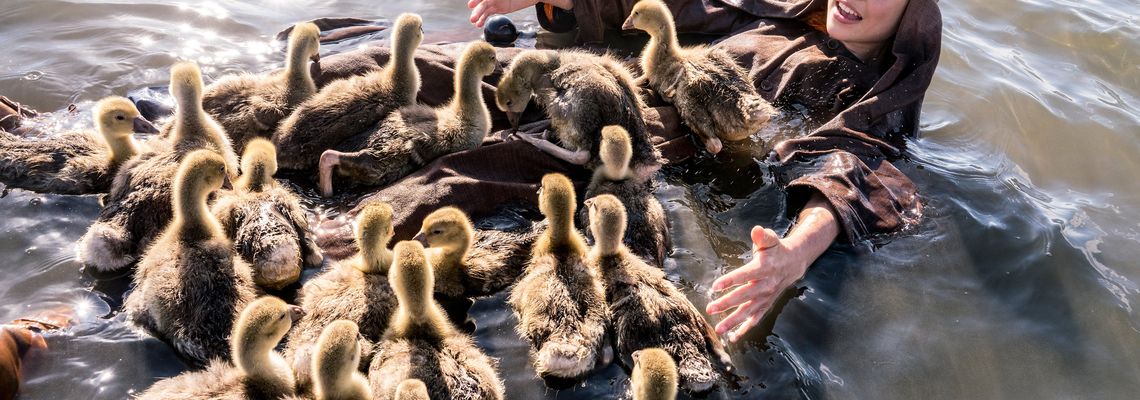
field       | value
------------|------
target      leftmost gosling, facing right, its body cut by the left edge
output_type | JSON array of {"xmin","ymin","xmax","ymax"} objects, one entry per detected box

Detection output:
[{"xmin": 0, "ymin": 96, "xmax": 153, "ymax": 195}]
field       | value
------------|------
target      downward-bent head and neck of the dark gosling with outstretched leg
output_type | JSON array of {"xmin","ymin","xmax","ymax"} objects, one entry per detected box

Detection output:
[{"xmin": 495, "ymin": 50, "xmax": 557, "ymax": 129}]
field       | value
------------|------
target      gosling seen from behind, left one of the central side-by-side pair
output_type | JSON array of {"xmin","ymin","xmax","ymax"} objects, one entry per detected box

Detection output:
[{"xmin": 507, "ymin": 173, "xmax": 612, "ymax": 379}]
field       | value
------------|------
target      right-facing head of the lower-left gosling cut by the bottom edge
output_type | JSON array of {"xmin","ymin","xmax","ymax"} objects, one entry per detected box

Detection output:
[{"xmin": 229, "ymin": 296, "xmax": 304, "ymax": 374}]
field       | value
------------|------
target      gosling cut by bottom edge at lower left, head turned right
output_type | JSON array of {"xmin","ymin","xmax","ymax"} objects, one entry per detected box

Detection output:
[{"xmin": 138, "ymin": 296, "xmax": 304, "ymax": 400}]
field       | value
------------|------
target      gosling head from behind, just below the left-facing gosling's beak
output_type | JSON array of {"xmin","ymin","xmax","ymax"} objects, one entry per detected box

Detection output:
[{"xmin": 388, "ymin": 240, "xmax": 435, "ymax": 320}]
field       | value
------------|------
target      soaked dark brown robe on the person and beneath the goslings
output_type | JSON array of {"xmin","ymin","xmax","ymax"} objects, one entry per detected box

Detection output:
[{"xmin": 315, "ymin": 0, "xmax": 942, "ymax": 242}]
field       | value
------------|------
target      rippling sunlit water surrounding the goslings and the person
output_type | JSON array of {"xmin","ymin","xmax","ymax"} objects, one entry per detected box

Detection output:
[{"xmin": 0, "ymin": 0, "xmax": 1140, "ymax": 399}]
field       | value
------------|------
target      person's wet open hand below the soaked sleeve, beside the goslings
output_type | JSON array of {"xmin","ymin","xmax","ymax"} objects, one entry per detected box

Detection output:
[{"xmin": 705, "ymin": 226, "xmax": 817, "ymax": 342}]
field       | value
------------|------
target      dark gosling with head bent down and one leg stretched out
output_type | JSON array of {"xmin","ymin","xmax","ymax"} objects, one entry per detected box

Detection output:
[{"xmin": 495, "ymin": 50, "xmax": 661, "ymax": 180}]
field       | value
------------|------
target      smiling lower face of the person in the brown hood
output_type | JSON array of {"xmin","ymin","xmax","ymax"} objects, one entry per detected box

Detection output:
[{"xmin": 828, "ymin": 0, "xmax": 907, "ymax": 50}]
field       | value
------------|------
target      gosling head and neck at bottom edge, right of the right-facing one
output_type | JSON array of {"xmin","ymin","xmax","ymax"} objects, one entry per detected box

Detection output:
[{"xmin": 311, "ymin": 319, "xmax": 372, "ymax": 400}]
